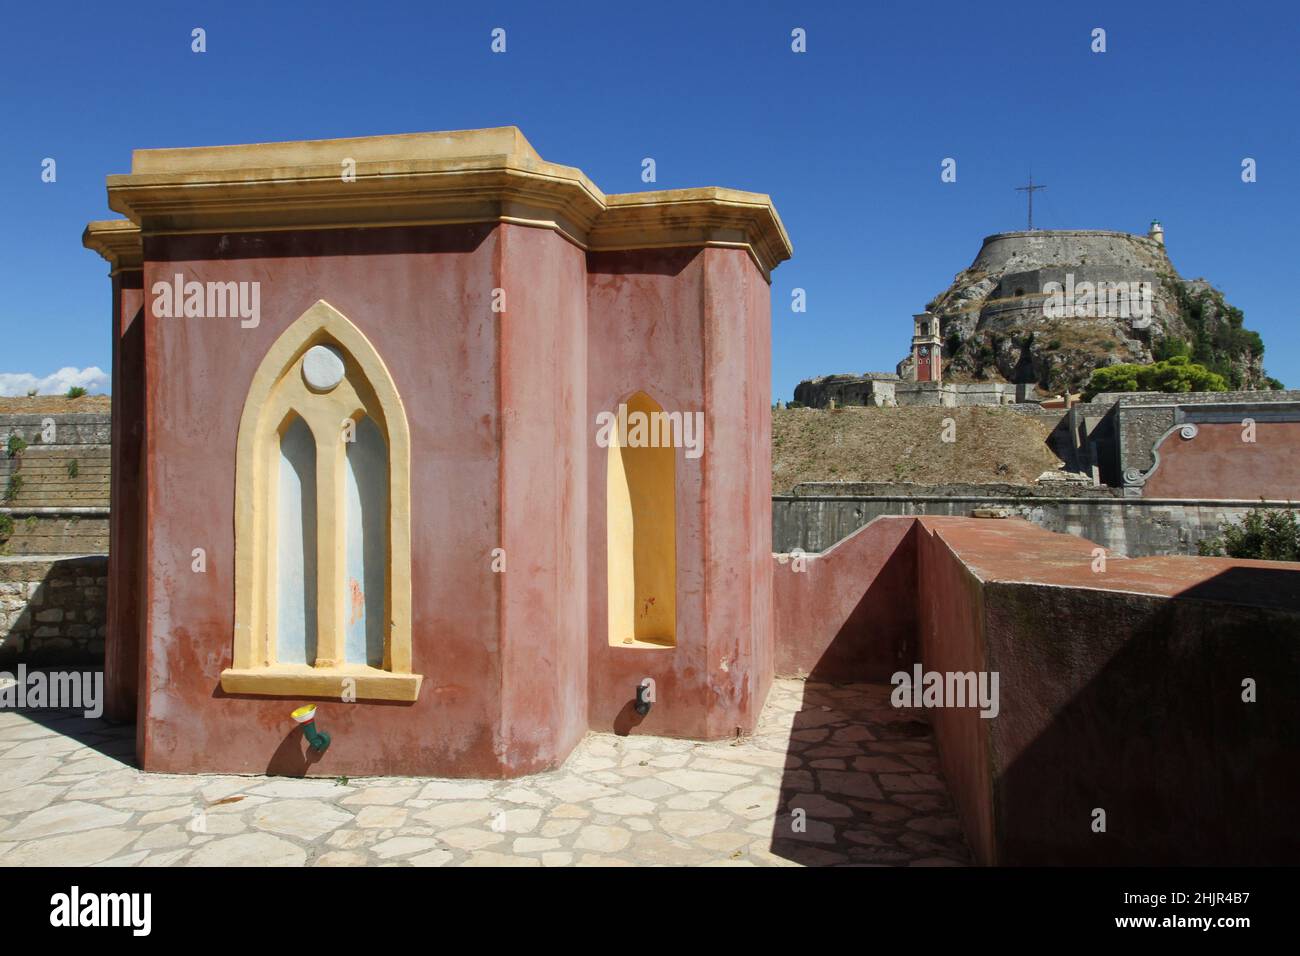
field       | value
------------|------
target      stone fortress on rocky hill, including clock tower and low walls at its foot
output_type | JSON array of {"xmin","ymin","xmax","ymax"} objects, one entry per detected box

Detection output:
[{"xmin": 794, "ymin": 221, "xmax": 1266, "ymax": 408}]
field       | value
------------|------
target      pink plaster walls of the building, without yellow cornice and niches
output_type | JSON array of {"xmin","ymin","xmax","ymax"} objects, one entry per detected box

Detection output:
[{"xmin": 130, "ymin": 225, "xmax": 774, "ymax": 777}]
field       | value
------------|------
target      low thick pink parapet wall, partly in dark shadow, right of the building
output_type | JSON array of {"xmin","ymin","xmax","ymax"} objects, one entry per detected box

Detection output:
[{"xmin": 774, "ymin": 518, "xmax": 1300, "ymax": 865}]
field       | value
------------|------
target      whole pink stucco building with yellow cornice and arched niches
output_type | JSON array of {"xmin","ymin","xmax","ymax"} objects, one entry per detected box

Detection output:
[{"xmin": 86, "ymin": 127, "xmax": 790, "ymax": 777}]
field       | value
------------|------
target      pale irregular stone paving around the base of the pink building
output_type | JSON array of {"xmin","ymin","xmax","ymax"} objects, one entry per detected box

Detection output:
[{"xmin": 0, "ymin": 680, "xmax": 970, "ymax": 866}]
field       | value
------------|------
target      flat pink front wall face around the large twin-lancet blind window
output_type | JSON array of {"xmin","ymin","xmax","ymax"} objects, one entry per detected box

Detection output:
[{"xmin": 142, "ymin": 226, "xmax": 520, "ymax": 777}]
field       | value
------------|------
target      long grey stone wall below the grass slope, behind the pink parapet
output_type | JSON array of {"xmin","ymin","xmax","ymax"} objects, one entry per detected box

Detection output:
[{"xmin": 772, "ymin": 493, "xmax": 1300, "ymax": 558}]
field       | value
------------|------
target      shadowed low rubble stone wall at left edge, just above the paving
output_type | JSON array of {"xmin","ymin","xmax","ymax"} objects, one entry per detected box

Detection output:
[{"xmin": 0, "ymin": 554, "xmax": 108, "ymax": 666}]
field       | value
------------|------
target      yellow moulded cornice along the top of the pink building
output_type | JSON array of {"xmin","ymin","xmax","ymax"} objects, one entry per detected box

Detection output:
[{"xmin": 98, "ymin": 126, "xmax": 792, "ymax": 274}]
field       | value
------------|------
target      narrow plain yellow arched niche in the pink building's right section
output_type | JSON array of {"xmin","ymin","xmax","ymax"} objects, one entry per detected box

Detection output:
[{"xmin": 605, "ymin": 392, "xmax": 677, "ymax": 648}]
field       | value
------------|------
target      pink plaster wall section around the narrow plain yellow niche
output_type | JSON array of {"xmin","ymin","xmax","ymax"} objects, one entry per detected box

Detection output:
[{"xmin": 588, "ymin": 248, "xmax": 772, "ymax": 737}]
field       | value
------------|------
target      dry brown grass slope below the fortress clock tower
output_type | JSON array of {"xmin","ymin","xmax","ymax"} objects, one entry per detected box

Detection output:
[{"xmin": 772, "ymin": 407, "xmax": 1061, "ymax": 494}]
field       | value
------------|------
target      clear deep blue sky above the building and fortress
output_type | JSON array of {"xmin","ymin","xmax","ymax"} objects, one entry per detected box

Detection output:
[{"xmin": 0, "ymin": 0, "xmax": 1300, "ymax": 399}]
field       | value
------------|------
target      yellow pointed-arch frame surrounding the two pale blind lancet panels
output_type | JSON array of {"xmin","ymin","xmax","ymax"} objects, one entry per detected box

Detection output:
[{"xmin": 221, "ymin": 299, "xmax": 421, "ymax": 701}]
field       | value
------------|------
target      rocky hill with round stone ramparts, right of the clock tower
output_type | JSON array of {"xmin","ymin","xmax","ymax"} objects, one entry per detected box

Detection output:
[{"xmin": 898, "ymin": 224, "xmax": 1281, "ymax": 393}]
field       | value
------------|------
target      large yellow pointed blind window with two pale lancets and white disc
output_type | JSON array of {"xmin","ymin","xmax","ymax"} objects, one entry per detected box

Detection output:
[{"xmin": 221, "ymin": 300, "xmax": 421, "ymax": 701}]
